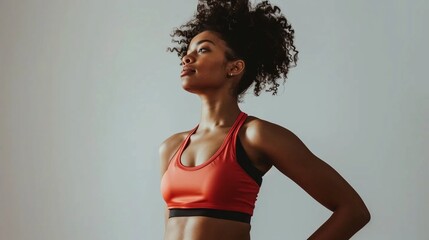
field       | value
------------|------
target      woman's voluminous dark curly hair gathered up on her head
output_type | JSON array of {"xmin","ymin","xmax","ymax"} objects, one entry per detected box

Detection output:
[{"xmin": 168, "ymin": 0, "xmax": 298, "ymax": 100}]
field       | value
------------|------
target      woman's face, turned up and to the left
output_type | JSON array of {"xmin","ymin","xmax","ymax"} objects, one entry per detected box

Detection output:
[{"xmin": 180, "ymin": 31, "xmax": 233, "ymax": 93}]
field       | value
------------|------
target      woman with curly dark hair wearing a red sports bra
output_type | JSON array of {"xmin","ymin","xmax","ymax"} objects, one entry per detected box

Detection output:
[{"xmin": 159, "ymin": 0, "xmax": 370, "ymax": 240}]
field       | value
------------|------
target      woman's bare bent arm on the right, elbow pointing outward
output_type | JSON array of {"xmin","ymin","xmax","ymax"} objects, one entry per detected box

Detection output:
[{"xmin": 246, "ymin": 120, "xmax": 370, "ymax": 240}]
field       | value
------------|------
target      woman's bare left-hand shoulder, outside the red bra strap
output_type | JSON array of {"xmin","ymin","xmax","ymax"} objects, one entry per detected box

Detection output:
[{"xmin": 158, "ymin": 131, "xmax": 190, "ymax": 173}]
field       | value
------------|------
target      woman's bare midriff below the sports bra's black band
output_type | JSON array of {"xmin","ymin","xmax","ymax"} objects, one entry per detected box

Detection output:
[{"xmin": 164, "ymin": 216, "xmax": 250, "ymax": 240}]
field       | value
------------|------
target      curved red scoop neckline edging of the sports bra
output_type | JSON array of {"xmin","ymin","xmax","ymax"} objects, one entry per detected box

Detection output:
[{"xmin": 177, "ymin": 112, "xmax": 244, "ymax": 170}]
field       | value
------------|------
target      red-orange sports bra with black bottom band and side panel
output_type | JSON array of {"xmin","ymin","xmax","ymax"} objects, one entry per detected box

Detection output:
[{"xmin": 161, "ymin": 112, "xmax": 263, "ymax": 223}]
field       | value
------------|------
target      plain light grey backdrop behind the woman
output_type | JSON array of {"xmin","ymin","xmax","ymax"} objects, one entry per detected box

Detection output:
[{"xmin": 0, "ymin": 0, "xmax": 429, "ymax": 240}]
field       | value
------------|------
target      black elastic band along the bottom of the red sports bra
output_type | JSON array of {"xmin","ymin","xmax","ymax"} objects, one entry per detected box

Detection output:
[{"xmin": 169, "ymin": 208, "xmax": 252, "ymax": 223}]
